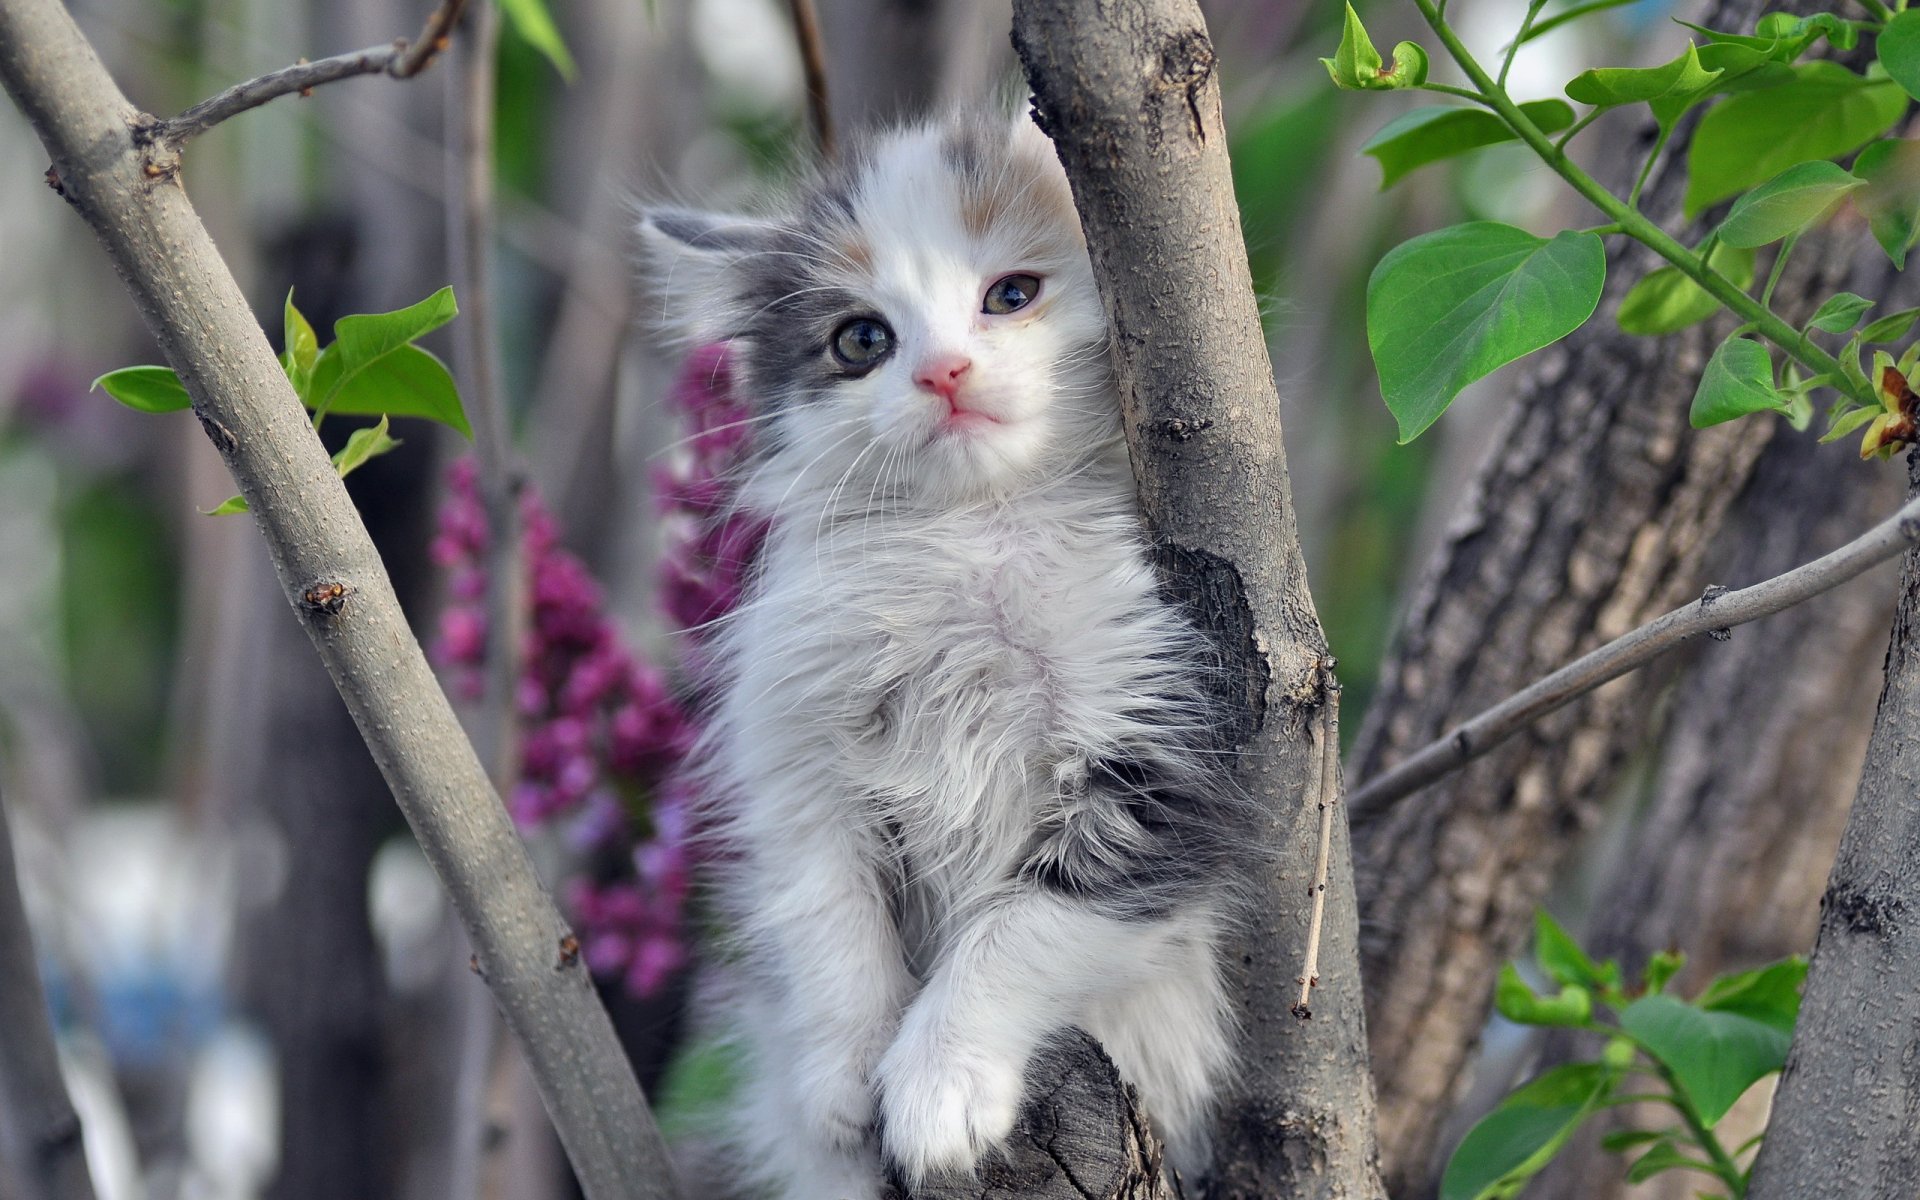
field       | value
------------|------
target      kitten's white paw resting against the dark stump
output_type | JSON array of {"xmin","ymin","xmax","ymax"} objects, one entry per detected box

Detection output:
[{"xmin": 877, "ymin": 1033, "xmax": 1023, "ymax": 1187}]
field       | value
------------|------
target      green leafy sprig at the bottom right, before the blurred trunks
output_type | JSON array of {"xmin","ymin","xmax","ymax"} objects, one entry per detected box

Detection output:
[{"xmin": 1440, "ymin": 912, "xmax": 1807, "ymax": 1200}]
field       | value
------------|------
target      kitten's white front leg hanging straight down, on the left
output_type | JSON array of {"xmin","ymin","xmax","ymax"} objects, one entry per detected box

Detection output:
[{"xmin": 745, "ymin": 808, "xmax": 912, "ymax": 1146}]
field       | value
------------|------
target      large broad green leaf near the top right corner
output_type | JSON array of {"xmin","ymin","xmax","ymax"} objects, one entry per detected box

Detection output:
[{"xmin": 1686, "ymin": 61, "xmax": 1907, "ymax": 217}]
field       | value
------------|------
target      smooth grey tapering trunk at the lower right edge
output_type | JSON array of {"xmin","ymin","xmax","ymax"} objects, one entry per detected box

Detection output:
[{"xmin": 1747, "ymin": 457, "xmax": 1920, "ymax": 1200}]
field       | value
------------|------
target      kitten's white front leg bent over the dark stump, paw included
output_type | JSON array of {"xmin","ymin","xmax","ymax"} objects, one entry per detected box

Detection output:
[{"xmin": 877, "ymin": 887, "xmax": 1167, "ymax": 1185}]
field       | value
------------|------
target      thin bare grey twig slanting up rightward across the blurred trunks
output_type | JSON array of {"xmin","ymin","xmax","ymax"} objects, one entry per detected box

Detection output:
[{"xmin": 1346, "ymin": 501, "xmax": 1920, "ymax": 820}]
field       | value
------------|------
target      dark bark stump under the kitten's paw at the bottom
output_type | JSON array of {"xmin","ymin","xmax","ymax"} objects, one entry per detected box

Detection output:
[{"xmin": 912, "ymin": 1031, "xmax": 1177, "ymax": 1200}]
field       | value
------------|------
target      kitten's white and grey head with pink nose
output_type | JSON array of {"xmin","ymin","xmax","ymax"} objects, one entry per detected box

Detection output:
[{"xmin": 641, "ymin": 119, "xmax": 1119, "ymax": 503}]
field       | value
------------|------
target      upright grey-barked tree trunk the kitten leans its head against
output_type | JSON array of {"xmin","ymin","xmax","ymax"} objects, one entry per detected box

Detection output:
[{"xmin": 1014, "ymin": 0, "xmax": 1380, "ymax": 1198}]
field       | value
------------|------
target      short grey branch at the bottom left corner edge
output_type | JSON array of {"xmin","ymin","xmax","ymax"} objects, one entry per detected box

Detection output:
[{"xmin": 0, "ymin": 791, "xmax": 94, "ymax": 1200}]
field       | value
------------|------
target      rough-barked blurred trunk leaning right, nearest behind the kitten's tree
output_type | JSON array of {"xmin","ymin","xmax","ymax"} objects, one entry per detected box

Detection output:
[{"xmin": 1350, "ymin": 0, "xmax": 1843, "ymax": 1196}]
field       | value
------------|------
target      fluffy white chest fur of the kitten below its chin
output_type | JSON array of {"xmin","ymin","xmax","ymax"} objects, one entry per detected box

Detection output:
[{"xmin": 735, "ymin": 466, "xmax": 1181, "ymax": 908}]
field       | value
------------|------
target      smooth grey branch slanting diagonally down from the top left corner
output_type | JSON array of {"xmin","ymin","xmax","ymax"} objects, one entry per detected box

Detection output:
[{"xmin": 0, "ymin": 0, "xmax": 676, "ymax": 1200}]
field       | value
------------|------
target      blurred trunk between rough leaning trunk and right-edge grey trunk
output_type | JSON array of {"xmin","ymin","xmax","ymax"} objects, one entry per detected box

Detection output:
[{"xmin": 1528, "ymin": 410, "xmax": 1905, "ymax": 1200}]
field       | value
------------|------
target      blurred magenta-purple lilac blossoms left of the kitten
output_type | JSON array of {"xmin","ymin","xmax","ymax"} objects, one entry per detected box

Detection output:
[{"xmin": 434, "ymin": 346, "xmax": 764, "ymax": 996}]
